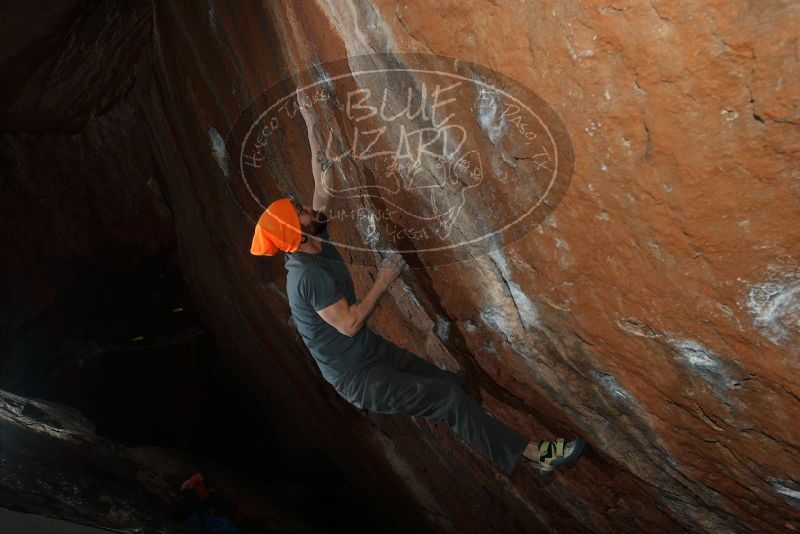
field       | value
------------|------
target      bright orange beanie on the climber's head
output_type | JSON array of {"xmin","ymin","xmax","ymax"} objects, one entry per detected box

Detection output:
[{"xmin": 250, "ymin": 198, "xmax": 302, "ymax": 256}]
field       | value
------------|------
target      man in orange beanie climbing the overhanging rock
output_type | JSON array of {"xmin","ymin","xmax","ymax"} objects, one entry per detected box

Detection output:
[{"xmin": 250, "ymin": 95, "xmax": 584, "ymax": 474}]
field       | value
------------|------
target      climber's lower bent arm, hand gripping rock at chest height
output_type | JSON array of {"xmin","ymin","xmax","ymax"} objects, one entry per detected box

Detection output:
[{"xmin": 317, "ymin": 254, "xmax": 406, "ymax": 337}]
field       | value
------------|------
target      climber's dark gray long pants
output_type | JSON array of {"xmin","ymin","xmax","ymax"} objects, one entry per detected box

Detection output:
[{"xmin": 332, "ymin": 340, "xmax": 530, "ymax": 474}]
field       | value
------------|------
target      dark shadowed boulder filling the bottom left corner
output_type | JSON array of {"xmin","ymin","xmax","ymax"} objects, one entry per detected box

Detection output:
[{"xmin": 0, "ymin": 390, "xmax": 340, "ymax": 533}]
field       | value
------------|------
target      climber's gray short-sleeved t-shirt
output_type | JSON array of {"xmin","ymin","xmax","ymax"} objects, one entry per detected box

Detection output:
[{"xmin": 285, "ymin": 229, "xmax": 382, "ymax": 383}]
